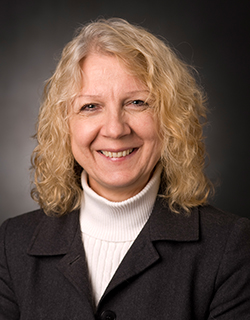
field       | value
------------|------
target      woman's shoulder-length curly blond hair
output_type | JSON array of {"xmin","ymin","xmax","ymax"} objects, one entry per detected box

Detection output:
[{"xmin": 31, "ymin": 18, "xmax": 212, "ymax": 215}]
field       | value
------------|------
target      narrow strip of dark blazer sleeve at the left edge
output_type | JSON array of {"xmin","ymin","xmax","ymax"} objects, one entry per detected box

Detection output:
[{"xmin": 0, "ymin": 220, "xmax": 20, "ymax": 320}]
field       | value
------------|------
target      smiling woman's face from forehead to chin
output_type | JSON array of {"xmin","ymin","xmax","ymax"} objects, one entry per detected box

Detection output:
[{"xmin": 69, "ymin": 53, "xmax": 161, "ymax": 201}]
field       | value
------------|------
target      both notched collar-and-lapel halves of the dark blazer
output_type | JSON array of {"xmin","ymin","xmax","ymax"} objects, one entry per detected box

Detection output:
[{"xmin": 25, "ymin": 197, "xmax": 199, "ymax": 307}]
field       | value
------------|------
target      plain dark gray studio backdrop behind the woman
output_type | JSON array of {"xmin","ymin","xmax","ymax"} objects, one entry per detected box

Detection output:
[{"xmin": 0, "ymin": 0, "xmax": 250, "ymax": 223}]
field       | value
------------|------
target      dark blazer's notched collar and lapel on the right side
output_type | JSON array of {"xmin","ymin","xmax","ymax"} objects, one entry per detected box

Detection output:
[{"xmin": 100, "ymin": 197, "xmax": 199, "ymax": 302}]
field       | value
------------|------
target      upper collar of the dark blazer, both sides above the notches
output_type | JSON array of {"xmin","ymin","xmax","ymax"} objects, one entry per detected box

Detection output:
[{"xmin": 28, "ymin": 197, "xmax": 199, "ymax": 256}]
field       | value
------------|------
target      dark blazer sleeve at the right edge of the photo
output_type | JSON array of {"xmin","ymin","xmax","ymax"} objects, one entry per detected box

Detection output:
[{"xmin": 209, "ymin": 218, "xmax": 250, "ymax": 320}]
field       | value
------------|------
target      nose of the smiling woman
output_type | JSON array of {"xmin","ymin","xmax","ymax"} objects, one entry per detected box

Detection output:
[{"xmin": 101, "ymin": 109, "xmax": 131, "ymax": 139}]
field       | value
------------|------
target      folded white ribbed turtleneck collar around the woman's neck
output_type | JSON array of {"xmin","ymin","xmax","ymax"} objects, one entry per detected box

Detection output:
[{"xmin": 80, "ymin": 164, "xmax": 162, "ymax": 242}]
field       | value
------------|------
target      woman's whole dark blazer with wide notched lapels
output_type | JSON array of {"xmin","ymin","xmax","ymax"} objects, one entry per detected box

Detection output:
[{"xmin": 0, "ymin": 199, "xmax": 250, "ymax": 320}]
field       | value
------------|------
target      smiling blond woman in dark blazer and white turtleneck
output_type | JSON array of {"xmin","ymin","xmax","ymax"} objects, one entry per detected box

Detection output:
[{"xmin": 0, "ymin": 19, "xmax": 250, "ymax": 320}]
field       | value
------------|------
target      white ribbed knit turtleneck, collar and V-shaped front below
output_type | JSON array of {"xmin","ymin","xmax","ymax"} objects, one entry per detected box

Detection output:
[{"xmin": 80, "ymin": 165, "xmax": 162, "ymax": 305}]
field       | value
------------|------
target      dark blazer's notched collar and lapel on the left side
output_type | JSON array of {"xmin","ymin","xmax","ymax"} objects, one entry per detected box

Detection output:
[{"xmin": 28, "ymin": 210, "xmax": 92, "ymax": 306}]
